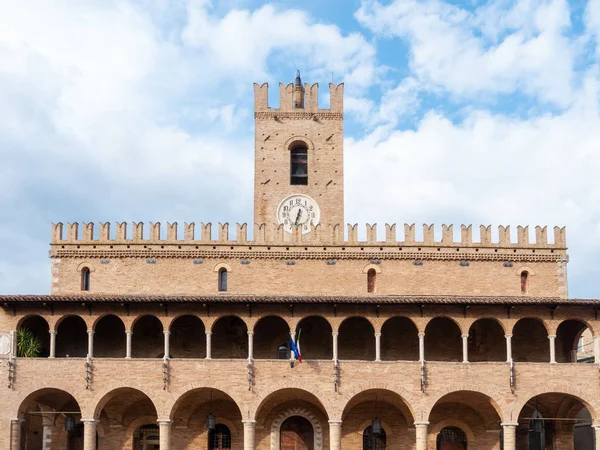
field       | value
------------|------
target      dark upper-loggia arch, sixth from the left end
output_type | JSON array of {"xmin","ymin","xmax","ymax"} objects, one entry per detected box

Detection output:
[{"xmin": 211, "ymin": 316, "xmax": 248, "ymax": 359}]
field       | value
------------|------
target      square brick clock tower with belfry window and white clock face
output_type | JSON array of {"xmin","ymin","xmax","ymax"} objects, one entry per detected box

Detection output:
[{"xmin": 254, "ymin": 72, "xmax": 344, "ymax": 233}]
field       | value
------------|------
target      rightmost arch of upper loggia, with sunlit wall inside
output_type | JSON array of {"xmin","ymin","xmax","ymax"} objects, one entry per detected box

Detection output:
[{"xmin": 555, "ymin": 320, "xmax": 594, "ymax": 363}]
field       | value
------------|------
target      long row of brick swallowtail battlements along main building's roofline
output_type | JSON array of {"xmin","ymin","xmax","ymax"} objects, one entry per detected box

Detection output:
[{"xmin": 52, "ymin": 222, "xmax": 567, "ymax": 250}]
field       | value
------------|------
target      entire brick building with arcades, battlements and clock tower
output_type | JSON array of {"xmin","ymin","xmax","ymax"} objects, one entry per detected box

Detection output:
[{"xmin": 0, "ymin": 76, "xmax": 600, "ymax": 450}]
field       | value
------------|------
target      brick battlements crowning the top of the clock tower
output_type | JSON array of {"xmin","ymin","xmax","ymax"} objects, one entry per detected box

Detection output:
[{"xmin": 254, "ymin": 83, "xmax": 344, "ymax": 115}]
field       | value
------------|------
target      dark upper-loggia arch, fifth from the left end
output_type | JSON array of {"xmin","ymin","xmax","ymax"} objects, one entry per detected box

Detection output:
[{"xmin": 169, "ymin": 315, "xmax": 206, "ymax": 358}]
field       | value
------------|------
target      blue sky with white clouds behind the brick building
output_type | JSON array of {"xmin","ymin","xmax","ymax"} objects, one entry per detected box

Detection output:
[{"xmin": 0, "ymin": 0, "xmax": 600, "ymax": 297}]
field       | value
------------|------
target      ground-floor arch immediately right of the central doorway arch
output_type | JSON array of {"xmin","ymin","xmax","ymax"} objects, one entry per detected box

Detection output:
[{"xmin": 342, "ymin": 389, "xmax": 416, "ymax": 450}]
